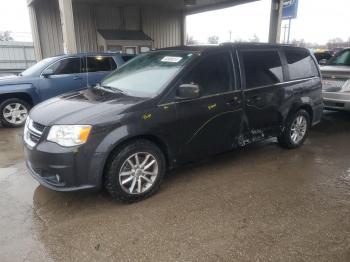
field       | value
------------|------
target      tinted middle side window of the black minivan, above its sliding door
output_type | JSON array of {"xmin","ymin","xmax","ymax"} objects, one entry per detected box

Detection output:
[{"xmin": 242, "ymin": 50, "xmax": 283, "ymax": 89}]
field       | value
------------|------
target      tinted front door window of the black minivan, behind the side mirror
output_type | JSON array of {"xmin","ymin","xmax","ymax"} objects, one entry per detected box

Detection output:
[{"xmin": 182, "ymin": 52, "xmax": 232, "ymax": 96}]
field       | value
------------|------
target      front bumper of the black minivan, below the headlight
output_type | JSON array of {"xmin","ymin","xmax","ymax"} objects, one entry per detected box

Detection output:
[{"xmin": 24, "ymin": 141, "xmax": 104, "ymax": 191}]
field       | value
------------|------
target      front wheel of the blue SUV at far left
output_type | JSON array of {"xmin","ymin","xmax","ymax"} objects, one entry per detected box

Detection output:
[{"xmin": 0, "ymin": 98, "xmax": 30, "ymax": 127}]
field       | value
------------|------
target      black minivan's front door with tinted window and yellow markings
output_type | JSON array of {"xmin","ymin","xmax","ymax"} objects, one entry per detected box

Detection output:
[{"xmin": 176, "ymin": 51, "xmax": 242, "ymax": 161}]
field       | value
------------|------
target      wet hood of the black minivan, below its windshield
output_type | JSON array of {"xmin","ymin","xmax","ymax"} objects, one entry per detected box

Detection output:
[{"xmin": 30, "ymin": 88, "xmax": 148, "ymax": 126}]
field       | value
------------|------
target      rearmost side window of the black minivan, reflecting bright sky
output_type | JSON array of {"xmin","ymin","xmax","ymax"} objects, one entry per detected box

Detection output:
[{"xmin": 285, "ymin": 50, "xmax": 318, "ymax": 80}]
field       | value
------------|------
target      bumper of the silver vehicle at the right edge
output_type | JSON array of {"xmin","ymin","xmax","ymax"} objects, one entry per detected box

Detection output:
[{"xmin": 323, "ymin": 92, "xmax": 350, "ymax": 111}]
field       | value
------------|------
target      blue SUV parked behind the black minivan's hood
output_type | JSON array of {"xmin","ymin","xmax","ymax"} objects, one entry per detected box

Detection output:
[{"xmin": 0, "ymin": 53, "xmax": 129, "ymax": 127}]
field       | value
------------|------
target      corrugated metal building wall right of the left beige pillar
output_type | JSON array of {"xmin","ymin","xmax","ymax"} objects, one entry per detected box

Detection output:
[{"xmin": 73, "ymin": 2, "xmax": 182, "ymax": 52}]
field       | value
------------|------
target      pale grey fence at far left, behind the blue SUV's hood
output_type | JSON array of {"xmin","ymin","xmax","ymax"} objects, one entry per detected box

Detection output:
[{"xmin": 0, "ymin": 42, "xmax": 35, "ymax": 74}]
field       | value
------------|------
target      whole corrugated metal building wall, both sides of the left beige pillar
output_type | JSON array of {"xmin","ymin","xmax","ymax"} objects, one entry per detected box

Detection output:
[{"xmin": 30, "ymin": 0, "xmax": 183, "ymax": 57}]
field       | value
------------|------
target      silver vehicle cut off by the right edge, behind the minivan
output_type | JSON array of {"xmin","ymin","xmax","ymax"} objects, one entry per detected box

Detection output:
[{"xmin": 321, "ymin": 48, "xmax": 350, "ymax": 111}]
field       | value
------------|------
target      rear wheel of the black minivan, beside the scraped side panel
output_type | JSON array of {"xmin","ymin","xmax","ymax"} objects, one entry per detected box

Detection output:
[{"xmin": 278, "ymin": 109, "xmax": 311, "ymax": 149}]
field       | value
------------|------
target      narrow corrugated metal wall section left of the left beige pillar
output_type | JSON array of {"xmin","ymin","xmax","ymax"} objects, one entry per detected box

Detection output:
[{"xmin": 35, "ymin": 0, "xmax": 63, "ymax": 57}]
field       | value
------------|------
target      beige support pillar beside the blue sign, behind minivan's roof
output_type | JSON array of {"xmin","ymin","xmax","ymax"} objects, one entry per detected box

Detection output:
[{"xmin": 269, "ymin": 0, "xmax": 283, "ymax": 44}]
